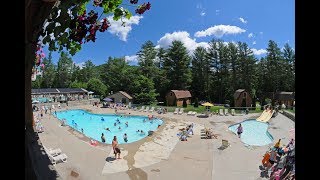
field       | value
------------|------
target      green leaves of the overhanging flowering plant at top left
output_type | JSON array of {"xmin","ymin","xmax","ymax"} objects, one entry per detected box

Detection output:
[{"xmin": 39, "ymin": 0, "xmax": 146, "ymax": 55}]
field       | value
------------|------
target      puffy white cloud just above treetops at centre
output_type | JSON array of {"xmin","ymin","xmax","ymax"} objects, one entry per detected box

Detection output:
[{"xmin": 156, "ymin": 31, "xmax": 209, "ymax": 53}]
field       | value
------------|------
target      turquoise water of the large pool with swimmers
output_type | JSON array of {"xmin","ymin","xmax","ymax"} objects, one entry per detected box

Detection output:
[{"xmin": 57, "ymin": 110, "xmax": 163, "ymax": 144}]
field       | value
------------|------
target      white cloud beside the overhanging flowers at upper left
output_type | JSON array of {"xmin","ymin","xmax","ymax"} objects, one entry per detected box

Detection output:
[{"xmin": 107, "ymin": 15, "xmax": 143, "ymax": 41}]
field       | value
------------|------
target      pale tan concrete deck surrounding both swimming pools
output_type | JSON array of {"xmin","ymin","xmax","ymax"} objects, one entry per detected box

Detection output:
[{"xmin": 39, "ymin": 105, "xmax": 294, "ymax": 180}]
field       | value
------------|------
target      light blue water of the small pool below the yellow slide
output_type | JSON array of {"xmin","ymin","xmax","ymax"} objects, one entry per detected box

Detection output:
[{"xmin": 229, "ymin": 119, "xmax": 273, "ymax": 146}]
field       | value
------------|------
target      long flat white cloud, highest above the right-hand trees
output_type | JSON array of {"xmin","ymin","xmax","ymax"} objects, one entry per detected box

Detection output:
[{"xmin": 194, "ymin": 25, "xmax": 246, "ymax": 38}]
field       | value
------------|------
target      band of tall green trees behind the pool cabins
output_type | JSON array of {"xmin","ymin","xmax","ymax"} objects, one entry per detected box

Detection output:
[{"xmin": 32, "ymin": 39, "xmax": 295, "ymax": 105}]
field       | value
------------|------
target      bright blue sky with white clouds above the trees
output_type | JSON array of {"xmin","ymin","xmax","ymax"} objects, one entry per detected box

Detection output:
[{"xmin": 45, "ymin": 0, "xmax": 295, "ymax": 65}]
